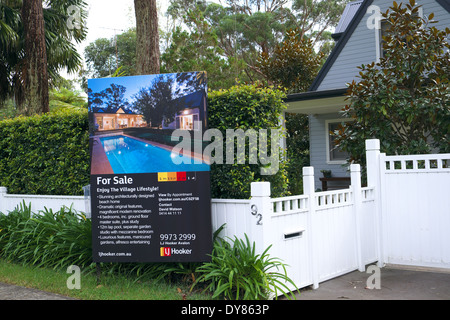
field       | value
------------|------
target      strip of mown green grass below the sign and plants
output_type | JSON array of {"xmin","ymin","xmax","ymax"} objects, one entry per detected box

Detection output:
[{"xmin": 0, "ymin": 259, "xmax": 211, "ymax": 300}]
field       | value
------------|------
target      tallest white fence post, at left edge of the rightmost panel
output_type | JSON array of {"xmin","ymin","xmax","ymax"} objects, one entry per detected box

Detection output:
[{"xmin": 366, "ymin": 139, "xmax": 384, "ymax": 268}]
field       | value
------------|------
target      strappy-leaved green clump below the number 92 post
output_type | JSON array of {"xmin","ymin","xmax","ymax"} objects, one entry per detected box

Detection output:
[{"xmin": 196, "ymin": 235, "xmax": 295, "ymax": 300}]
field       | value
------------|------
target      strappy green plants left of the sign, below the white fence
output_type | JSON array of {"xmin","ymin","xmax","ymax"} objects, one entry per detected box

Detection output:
[{"xmin": 0, "ymin": 204, "xmax": 92, "ymax": 268}]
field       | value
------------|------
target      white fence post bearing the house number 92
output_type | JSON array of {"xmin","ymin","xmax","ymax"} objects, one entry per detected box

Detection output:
[{"xmin": 249, "ymin": 182, "xmax": 273, "ymax": 254}]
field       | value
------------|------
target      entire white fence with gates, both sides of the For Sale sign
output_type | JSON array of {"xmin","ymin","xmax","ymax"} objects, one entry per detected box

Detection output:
[{"xmin": 0, "ymin": 139, "xmax": 450, "ymax": 289}]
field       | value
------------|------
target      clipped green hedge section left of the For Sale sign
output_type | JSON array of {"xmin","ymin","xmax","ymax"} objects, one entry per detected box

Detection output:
[{"xmin": 0, "ymin": 110, "xmax": 90, "ymax": 195}]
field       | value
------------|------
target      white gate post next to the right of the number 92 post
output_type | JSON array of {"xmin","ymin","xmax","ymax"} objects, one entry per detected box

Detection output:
[{"xmin": 303, "ymin": 167, "xmax": 319, "ymax": 289}]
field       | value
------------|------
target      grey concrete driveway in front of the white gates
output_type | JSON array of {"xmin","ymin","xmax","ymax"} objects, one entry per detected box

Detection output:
[{"xmin": 297, "ymin": 267, "xmax": 450, "ymax": 300}]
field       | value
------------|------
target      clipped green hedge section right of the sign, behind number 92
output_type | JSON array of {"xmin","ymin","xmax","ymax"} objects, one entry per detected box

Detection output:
[{"xmin": 208, "ymin": 84, "xmax": 288, "ymax": 199}]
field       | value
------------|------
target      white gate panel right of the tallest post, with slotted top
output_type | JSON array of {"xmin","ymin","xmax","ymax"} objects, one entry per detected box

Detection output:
[{"xmin": 380, "ymin": 154, "xmax": 450, "ymax": 268}]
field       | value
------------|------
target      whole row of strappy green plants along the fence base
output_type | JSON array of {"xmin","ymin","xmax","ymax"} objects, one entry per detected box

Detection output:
[{"xmin": 0, "ymin": 203, "xmax": 295, "ymax": 300}]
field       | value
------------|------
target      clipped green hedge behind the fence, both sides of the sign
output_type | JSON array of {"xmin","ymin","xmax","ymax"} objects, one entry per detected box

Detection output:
[{"xmin": 0, "ymin": 85, "xmax": 289, "ymax": 199}]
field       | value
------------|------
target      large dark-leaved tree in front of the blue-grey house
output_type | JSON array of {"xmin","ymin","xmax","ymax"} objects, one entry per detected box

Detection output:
[{"xmin": 335, "ymin": 0, "xmax": 450, "ymax": 164}]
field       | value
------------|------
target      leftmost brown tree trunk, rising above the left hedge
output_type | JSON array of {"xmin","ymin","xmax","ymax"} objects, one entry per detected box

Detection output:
[{"xmin": 20, "ymin": 0, "xmax": 49, "ymax": 115}]
